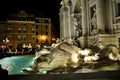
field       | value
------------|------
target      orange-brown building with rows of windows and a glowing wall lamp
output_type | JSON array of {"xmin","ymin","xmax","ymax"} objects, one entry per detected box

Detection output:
[{"xmin": 0, "ymin": 11, "xmax": 55, "ymax": 48}]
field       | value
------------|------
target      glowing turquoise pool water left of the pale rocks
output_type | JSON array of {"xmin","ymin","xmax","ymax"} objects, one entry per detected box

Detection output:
[{"xmin": 0, "ymin": 55, "xmax": 34, "ymax": 75}]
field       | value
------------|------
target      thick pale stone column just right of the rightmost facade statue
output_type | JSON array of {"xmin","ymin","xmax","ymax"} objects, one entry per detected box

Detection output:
[{"xmin": 96, "ymin": 0, "xmax": 106, "ymax": 34}]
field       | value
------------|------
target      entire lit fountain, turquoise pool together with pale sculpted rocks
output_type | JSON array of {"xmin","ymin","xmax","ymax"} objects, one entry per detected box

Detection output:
[{"xmin": 0, "ymin": 35, "xmax": 120, "ymax": 74}]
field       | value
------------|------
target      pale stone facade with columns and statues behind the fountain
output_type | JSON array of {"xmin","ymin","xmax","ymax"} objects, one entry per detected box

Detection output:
[{"xmin": 59, "ymin": 0, "xmax": 120, "ymax": 47}]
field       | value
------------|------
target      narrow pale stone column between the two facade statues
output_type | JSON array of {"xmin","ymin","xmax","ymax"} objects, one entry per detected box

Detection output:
[{"xmin": 81, "ymin": 0, "xmax": 87, "ymax": 36}]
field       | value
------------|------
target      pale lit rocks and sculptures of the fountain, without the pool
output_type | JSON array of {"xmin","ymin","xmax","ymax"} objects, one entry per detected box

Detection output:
[{"xmin": 23, "ymin": 39, "xmax": 120, "ymax": 74}]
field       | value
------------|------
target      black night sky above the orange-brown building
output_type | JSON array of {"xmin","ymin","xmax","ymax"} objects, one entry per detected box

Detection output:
[{"xmin": 0, "ymin": 0, "xmax": 61, "ymax": 37}]
